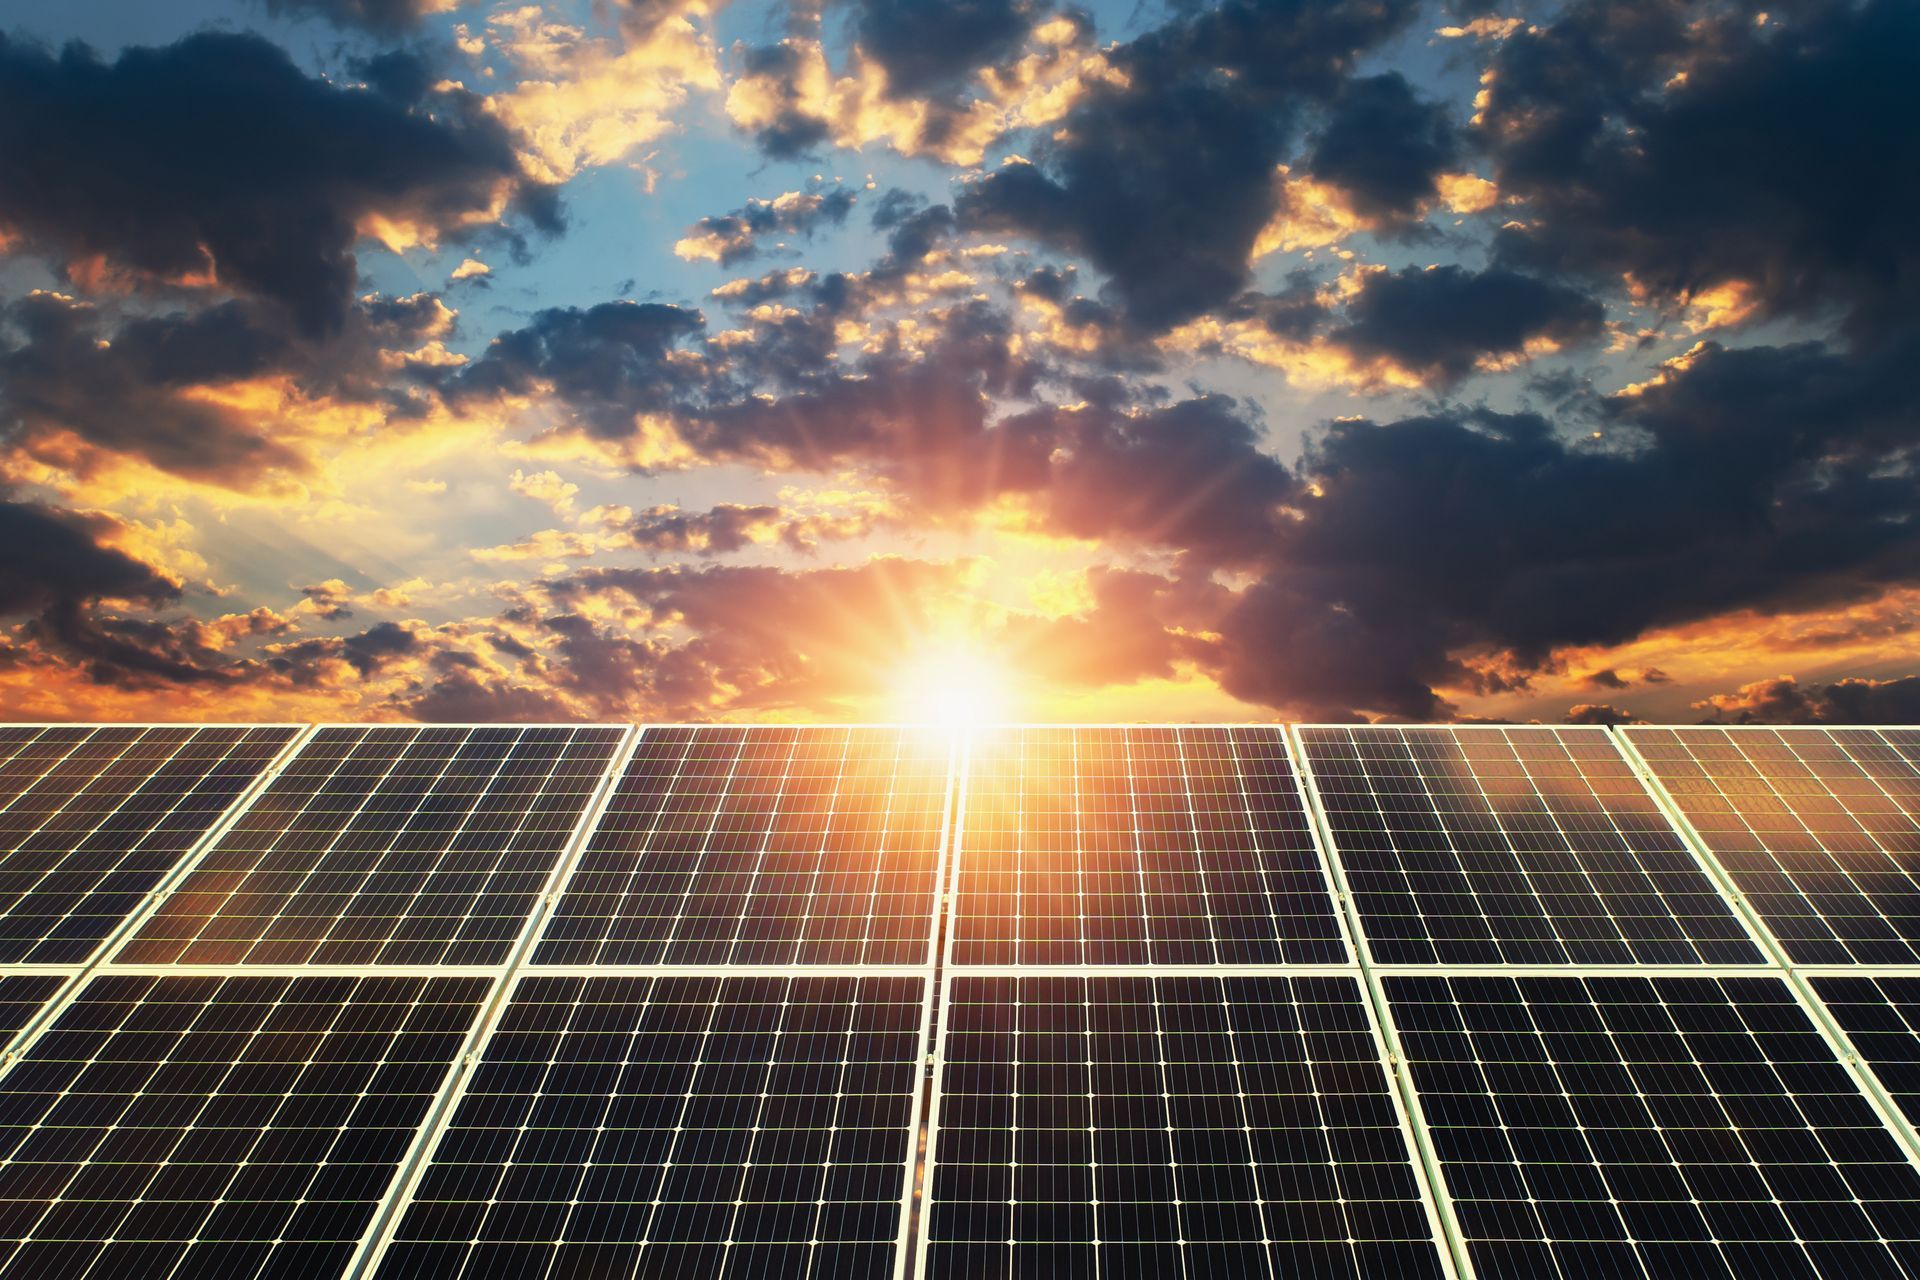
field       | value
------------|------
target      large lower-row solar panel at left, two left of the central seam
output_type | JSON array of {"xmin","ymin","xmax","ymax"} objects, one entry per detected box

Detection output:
[{"xmin": 0, "ymin": 973, "xmax": 490, "ymax": 1280}]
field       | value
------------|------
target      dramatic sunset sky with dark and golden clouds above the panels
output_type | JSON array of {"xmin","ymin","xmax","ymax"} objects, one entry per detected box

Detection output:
[{"xmin": 0, "ymin": 0, "xmax": 1920, "ymax": 723}]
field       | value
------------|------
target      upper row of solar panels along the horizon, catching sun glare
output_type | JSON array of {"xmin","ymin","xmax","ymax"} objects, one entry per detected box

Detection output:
[{"xmin": 0, "ymin": 725, "xmax": 1920, "ymax": 967}]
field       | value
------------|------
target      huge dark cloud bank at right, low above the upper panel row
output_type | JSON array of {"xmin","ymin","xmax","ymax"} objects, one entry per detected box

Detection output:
[{"xmin": 1219, "ymin": 326, "xmax": 1920, "ymax": 718}]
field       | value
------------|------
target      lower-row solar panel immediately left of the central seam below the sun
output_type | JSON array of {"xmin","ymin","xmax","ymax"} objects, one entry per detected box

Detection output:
[{"xmin": 378, "ymin": 975, "xmax": 925, "ymax": 1280}]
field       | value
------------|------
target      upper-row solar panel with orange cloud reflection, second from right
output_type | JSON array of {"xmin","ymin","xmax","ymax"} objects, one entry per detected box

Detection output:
[{"xmin": 1300, "ymin": 725, "xmax": 1763, "ymax": 965}]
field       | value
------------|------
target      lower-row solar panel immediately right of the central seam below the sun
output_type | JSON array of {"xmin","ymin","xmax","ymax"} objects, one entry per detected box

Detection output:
[{"xmin": 927, "ymin": 975, "xmax": 1442, "ymax": 1280}]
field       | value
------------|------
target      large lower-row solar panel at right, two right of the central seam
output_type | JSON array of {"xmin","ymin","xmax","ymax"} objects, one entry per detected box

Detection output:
[{"xmin": 1384, "ymin": 975, "xmax": 1920, "ymax": 1280}]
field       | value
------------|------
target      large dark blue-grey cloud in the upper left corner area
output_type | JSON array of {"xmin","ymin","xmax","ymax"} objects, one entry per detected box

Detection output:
[{"xmin": 0, "ymin": 33, "xmax": 557, "ymax": 334}]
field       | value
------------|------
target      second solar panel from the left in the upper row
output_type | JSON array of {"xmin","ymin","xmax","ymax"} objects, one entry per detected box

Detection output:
[{"xmin": 115, "ymin": 725, "xmax": 624, "ymax": 965}]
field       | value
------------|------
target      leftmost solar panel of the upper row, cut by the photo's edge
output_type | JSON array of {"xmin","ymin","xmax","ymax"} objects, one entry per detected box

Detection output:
[{"xmin": 0, "ymin": 725, "xmax": 298, "ymax": 963}]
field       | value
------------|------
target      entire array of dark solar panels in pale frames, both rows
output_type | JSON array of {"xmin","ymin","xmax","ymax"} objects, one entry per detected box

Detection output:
[{"xmin": 0, "ymin": 725, "xmax": 1920, "ymax": 1280}]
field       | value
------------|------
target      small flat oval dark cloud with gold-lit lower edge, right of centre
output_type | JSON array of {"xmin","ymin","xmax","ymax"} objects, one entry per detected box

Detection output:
[{"xmin": 1329, "ymin": 267, "xmax": 1605, "ymax": 386}]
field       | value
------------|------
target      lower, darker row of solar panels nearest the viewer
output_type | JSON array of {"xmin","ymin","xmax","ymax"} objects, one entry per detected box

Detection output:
[{"xmin": 0, "ymin": 971, "xmax": 1920, "ymax": 1280}]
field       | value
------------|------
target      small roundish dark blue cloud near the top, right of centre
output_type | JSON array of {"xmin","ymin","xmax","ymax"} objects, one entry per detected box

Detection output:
[{"xmin": 1308, "ymin": 71, "xmax": 1459, "ymax": 219}]
